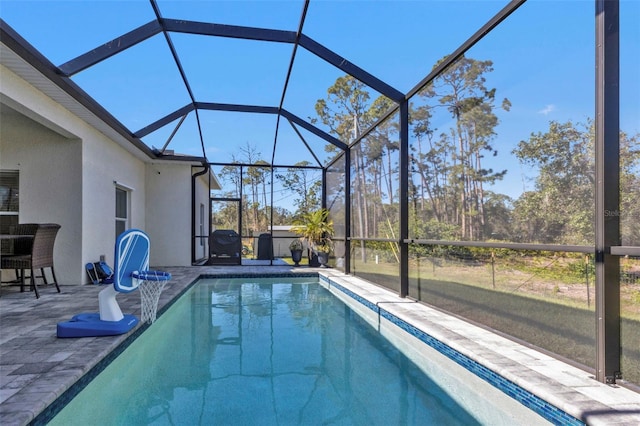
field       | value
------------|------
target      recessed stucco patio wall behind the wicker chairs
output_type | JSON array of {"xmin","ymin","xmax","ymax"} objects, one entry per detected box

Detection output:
[{"xmin": 0, "ymin": 104, "xmax": 82, "ymax": 283}]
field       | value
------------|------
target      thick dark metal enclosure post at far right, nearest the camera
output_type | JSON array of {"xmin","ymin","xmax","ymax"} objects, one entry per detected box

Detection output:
[{"xmin": 595, "ymin": 0, "xmax": 621, "ymax": 383}]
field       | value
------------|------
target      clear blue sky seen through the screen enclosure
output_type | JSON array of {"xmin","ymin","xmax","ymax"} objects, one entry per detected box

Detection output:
[{"xmin": 0, "ymin": 0, "xmax": 640, "ymax": 202}]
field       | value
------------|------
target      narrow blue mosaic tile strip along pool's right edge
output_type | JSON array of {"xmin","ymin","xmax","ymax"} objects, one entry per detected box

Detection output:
[{"xmin": 319, "ymin": 274, "xmax": 585, "ymax": 426}]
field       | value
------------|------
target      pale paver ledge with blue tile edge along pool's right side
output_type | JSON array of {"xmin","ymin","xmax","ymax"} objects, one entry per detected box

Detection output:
[{"xmin": 321, "ymin": 273, "xmax": 640, "ymax": 426}]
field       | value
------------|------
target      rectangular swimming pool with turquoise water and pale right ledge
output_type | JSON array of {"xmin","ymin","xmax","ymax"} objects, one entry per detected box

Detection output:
[{"xmin": 50, "ymin": 278, "xmax": 545, "ymax": 425}]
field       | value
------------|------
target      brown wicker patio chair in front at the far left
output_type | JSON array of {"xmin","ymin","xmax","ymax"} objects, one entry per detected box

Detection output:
[{"xmin": 0, "ymin": 223, "xmax": 60, "ymax": 298}]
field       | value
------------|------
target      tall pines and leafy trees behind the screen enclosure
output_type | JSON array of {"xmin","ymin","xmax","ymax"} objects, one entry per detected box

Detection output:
[{"xmin": 212, "ymin": 57, "xmax": 640, "ymax": 250}]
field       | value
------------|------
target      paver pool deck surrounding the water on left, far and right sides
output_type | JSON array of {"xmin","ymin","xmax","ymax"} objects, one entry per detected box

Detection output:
[{"xmin": 0, "ymin": 265, "xmax": 640, "ymax": 426}]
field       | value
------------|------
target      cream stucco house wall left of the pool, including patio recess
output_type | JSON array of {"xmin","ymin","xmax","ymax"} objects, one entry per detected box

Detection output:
[{"xmin": 0, "ymin": 62, "xmax": 202, "ymax": 284}]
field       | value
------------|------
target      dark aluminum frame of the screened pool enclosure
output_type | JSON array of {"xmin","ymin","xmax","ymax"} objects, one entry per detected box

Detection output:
[{"xmin": 0, "ymin": 0, "xmax": 639, "ymax": 383}]
